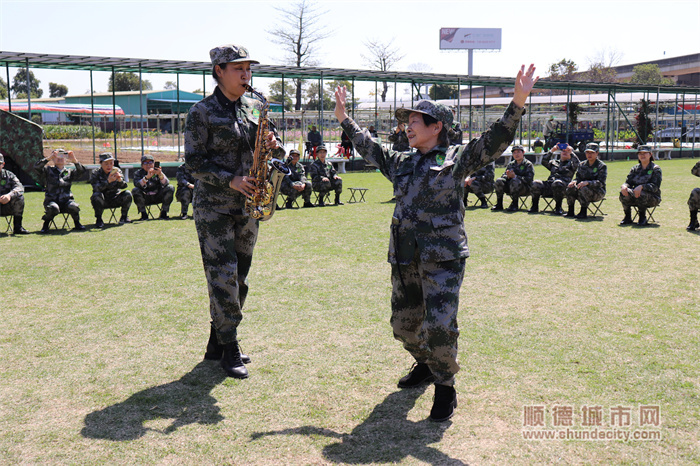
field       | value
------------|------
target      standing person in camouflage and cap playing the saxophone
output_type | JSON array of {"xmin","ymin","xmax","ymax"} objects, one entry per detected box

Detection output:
[{"xmin": 185, "ymin": 45, "xmax": 284, "ymax": 379}]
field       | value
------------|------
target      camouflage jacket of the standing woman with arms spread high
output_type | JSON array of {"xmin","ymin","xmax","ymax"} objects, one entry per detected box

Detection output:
[{"xmin": 342, "ymin": 103, "xmax": 524, "ymax": 264}]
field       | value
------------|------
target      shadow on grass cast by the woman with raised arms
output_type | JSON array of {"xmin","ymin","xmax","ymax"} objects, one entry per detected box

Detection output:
[{"xmin": 251, "ymin": 385, "xmax": 466, "ymax": 465}]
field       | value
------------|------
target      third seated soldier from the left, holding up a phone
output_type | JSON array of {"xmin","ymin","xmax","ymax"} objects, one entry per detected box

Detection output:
[{"xmin": 90, "ymin": 152, "xmax": 132, "ymax": 228}]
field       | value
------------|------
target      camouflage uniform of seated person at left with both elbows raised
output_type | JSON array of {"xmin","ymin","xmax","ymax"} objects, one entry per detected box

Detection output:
[{"xmin": 34, "ymin": 159, "xmax": 85, "ymax": 223}]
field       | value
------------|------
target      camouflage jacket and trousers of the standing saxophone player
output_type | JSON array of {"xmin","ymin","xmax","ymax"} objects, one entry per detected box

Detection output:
[{"xmin": 185, "ymin": 86, "xmax": 284, "ymax": 344}]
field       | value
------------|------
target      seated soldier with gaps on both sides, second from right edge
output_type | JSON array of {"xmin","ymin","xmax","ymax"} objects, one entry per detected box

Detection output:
[{"xmin": 620, "ymin": 146, "xmax": 661, "ymax": 226}]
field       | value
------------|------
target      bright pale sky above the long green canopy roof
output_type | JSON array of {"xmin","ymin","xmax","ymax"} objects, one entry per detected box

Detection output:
[{"xmin": 0, "ymin": 0, "xmax": 700, "ymax": 99}]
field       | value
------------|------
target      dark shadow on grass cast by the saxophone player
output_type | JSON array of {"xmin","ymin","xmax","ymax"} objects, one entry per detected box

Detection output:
[{"xmin": 80, "ymin": 361, "xmax": 226, "ymax": 441}]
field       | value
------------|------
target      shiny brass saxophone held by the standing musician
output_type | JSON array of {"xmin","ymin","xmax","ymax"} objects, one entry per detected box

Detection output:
[{"xmin": 245, "ymin": 84, "xmax": 292, "ymax": 220}]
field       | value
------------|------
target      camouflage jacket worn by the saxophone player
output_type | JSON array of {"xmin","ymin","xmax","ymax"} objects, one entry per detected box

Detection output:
[{"xmin": 185, "ymin": 86, "xmax": 284, "ymax": 209}]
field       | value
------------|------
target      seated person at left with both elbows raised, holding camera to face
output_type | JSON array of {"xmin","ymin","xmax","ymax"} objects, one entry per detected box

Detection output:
[{"xmin": 34, "ymin": 149, "xmax": 85, "ymax": 233}]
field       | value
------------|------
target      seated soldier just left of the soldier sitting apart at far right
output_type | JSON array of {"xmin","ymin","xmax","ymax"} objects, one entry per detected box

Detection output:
[{"xmin": 566, "ymin": 143, "xmax": 608, "ymax": 219}]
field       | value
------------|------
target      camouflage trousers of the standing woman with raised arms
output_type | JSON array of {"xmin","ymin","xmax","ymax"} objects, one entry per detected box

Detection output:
[{"xmin": 391, "ymin": 257, "xmax": 465, "ymax": 385}]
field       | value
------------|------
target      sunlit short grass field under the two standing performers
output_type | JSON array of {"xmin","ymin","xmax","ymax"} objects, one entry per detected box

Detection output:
[{"xmin": 0, "ymin": 159, "xmax": 700, "ymax": 465}]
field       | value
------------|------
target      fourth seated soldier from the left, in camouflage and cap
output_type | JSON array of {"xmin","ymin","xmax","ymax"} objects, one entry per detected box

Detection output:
[{"xmin": 131, "ymin": 155, "xmax": 175, "ymax": 220}]
